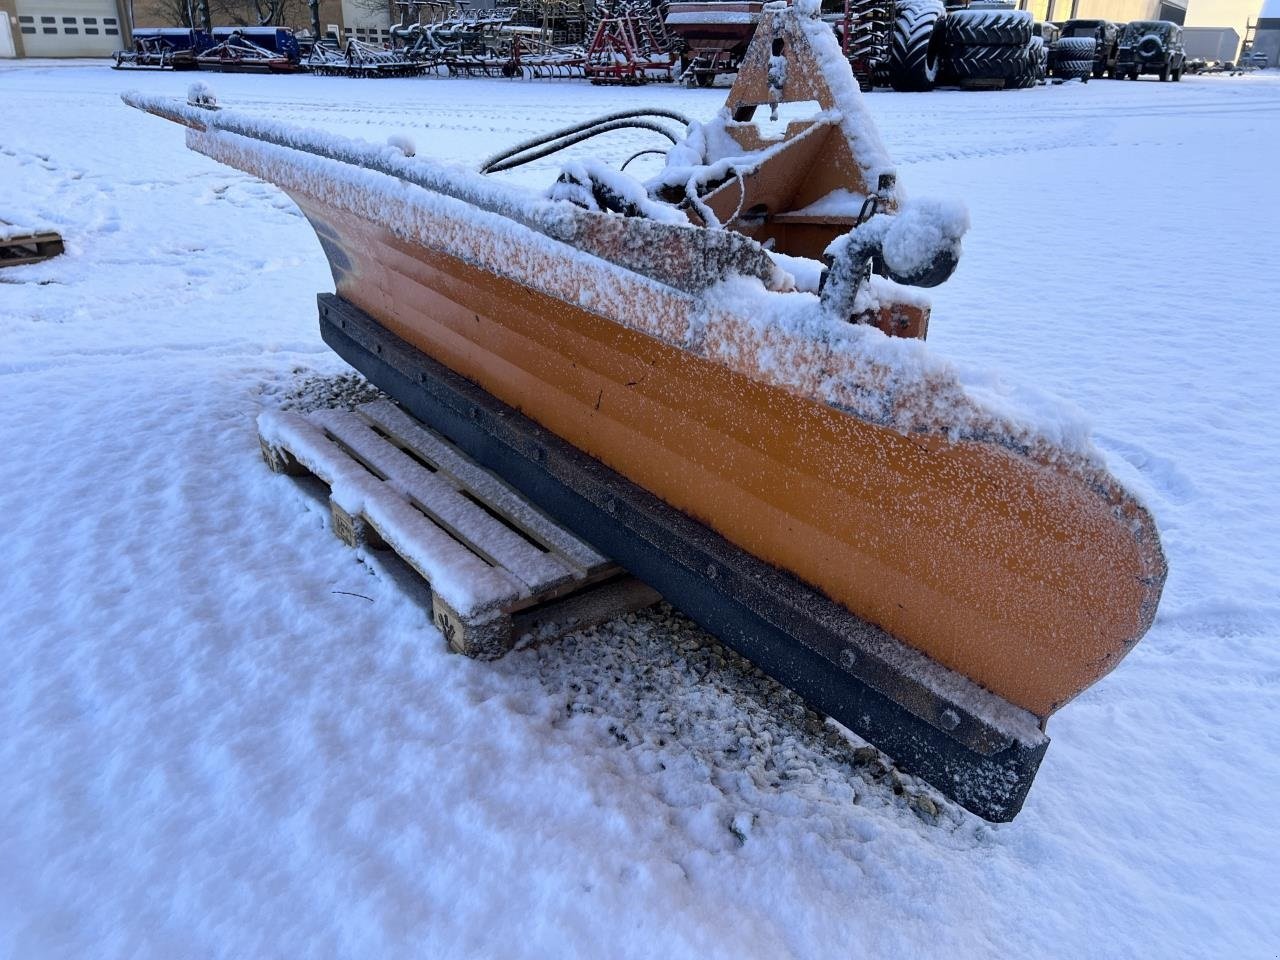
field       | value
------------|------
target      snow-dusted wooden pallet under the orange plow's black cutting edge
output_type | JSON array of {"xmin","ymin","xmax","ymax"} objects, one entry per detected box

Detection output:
[{"xmin": 259, "ymin": 401, "xmax": 659, "ymax": 659}]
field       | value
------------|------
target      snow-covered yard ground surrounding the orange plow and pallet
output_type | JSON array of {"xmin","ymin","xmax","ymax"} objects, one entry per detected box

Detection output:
[{"xmin": 0, "ymin": 63, "xmax": 1280, "ymax": 960}]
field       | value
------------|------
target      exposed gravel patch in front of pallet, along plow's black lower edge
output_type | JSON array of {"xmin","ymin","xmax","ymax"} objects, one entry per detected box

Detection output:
[{"xmin": 514, "ymin": 603, "xmax": 947, "ymax": 842}]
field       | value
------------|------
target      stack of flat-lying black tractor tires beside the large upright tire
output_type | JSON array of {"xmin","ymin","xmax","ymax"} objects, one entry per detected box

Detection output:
[{"xmin": 946, "ymin": 8, "xmax": 1039, "ymax": 88}]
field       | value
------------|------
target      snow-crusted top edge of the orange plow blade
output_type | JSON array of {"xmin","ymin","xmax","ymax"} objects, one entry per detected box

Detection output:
[{"xmin": 122, "ymin": 92, "xmax": 1116, "ymax": 481}]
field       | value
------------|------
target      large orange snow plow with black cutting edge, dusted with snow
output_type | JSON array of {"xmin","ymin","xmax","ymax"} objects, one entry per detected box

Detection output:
[{"xmin": 125, "ymin": 3, "xmax": 1165, "ymax": 820}]
